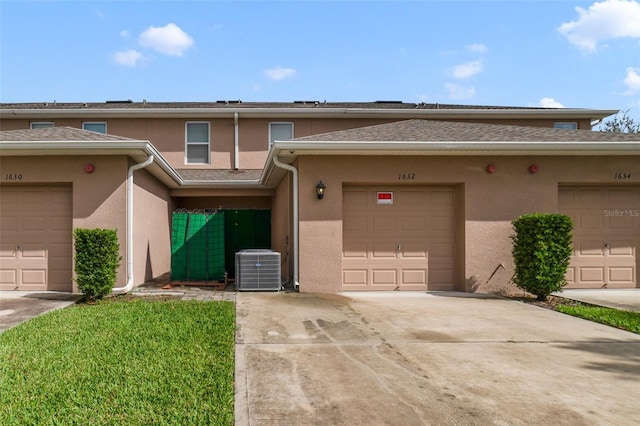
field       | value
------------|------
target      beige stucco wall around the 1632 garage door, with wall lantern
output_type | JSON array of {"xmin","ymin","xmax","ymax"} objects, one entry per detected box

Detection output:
[{"xmin": 298, "ymin": 156, "xmax": 640, "ymax": 293}]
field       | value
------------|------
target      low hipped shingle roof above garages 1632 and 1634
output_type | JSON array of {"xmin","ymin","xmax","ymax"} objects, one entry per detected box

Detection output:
[{"xmin": 295, "ymin": 119, "xmax": 640, "ymax": 142}]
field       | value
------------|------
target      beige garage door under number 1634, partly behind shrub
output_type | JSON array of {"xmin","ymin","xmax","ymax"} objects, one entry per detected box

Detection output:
[{"xmin": 559, "ymin": 186, "xmax": 640, "ymax": 288}]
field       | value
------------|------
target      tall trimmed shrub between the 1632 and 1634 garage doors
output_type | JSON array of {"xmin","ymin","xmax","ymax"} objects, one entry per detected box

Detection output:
[{"xmin": 511, "ymin": 213, "xmax": 573, "ymax": 300}]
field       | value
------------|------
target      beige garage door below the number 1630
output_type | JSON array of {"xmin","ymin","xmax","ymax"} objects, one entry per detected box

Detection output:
[{"xmin": 0, "ymin": 185, "xmax": 72, "ymax": 292}]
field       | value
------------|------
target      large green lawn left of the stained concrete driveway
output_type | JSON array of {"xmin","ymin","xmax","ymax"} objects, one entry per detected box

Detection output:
[{"xmin": 0, "ymin": 300, "xmax": 235, "ymax": 425}]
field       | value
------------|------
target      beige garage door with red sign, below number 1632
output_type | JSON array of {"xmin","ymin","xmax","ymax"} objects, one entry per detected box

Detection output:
[{"xmin": 342, "ymin": 186, "xmax": 456, "ymax": 291}]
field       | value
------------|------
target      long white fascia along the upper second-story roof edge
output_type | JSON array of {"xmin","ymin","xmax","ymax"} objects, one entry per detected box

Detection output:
[{"xmin": 0, "ymin": 107, "xmax": 618, "ymax": 120}]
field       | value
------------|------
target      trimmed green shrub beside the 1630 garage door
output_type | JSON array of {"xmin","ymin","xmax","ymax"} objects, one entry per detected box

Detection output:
[{"xmin": 73, "ymin": 228, "xmax": 122, "ymax": 300}]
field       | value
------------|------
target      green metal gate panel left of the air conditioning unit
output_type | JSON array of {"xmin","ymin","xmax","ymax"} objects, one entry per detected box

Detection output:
[{"xmin": 171, "ymin": 211, "xmax": 225, "ymax": 281}]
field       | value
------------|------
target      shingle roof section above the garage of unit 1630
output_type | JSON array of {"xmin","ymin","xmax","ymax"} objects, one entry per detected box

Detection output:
[{"xmin": 0, "ymin": 126, "xmax": 135, "ymax": 142}]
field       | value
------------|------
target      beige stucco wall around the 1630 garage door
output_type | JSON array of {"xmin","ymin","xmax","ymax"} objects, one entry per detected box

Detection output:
[{"xmin": 0, "ymin": 156, "xmax": 127, "ymax": 292}]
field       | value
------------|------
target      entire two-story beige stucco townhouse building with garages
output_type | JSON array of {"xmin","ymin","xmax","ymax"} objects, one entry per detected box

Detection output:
[{"xmin": 0, "ymin": 101, "xmax": 640, "ymax": 293}]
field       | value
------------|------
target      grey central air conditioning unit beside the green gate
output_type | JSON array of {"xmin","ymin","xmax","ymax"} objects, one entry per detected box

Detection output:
[{"xmin": 236, "ymin": 249, "xmax": 282, "ymax": 291}]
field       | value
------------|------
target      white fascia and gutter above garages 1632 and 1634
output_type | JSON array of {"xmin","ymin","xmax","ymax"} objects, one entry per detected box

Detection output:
[{"xmin": 273, "ymin": 141, "xmax": 640, "ymax": 158}]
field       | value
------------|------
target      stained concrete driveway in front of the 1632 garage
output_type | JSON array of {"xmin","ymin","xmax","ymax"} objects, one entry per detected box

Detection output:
[{"xmin": 236, "ymin": 292, "xmax": 640, "ymax": 425}]
